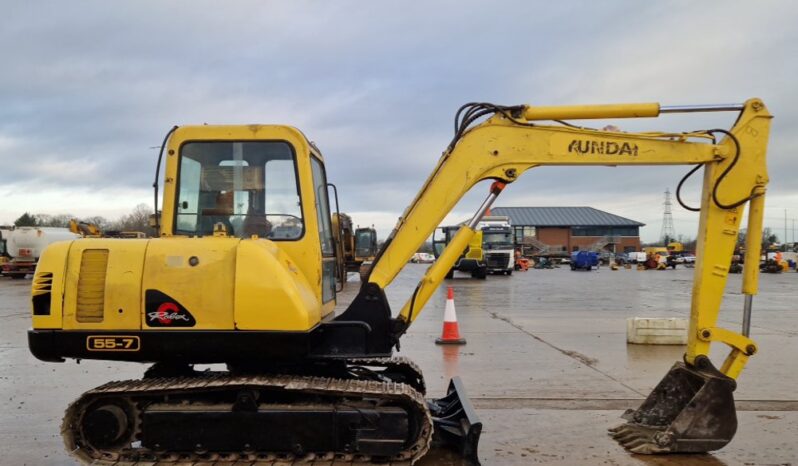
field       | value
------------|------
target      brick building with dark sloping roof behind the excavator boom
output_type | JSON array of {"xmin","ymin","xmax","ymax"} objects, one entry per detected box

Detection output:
[{"xmin": 491, "ymin": 207, "xmax": 645, "ymax": 255}]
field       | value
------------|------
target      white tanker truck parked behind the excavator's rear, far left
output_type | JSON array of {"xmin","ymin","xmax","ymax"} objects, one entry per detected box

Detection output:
[{"xmin": 3, "ymin": 227, "xmax": 80, "ymax": 278}]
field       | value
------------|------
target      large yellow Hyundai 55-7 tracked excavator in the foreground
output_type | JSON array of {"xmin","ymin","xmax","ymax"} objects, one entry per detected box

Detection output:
[{"xmin": 29, "ymin": 99, "xmax": 771, "ymax": 465}]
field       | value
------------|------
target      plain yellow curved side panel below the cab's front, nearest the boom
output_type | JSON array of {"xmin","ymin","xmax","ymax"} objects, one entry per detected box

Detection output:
[{"xmin": 235, "ymin": 240, "xmax": 322, "ymax": 331}]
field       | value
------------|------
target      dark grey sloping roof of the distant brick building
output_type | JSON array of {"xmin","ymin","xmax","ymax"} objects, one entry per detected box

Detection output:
[{"xmin": 490, "ymin": 207, "xmax": 645, "ymax": 227}]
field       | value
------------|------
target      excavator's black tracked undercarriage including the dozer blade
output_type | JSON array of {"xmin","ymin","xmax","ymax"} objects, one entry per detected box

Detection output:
[{"xmin": 62, "ymin": 358, "xmax": 481, "ymax": 466}]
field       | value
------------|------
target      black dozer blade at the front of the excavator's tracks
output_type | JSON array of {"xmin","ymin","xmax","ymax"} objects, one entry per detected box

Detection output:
[{"xmin": 427, "ymin": 377, "xmax": 482, "ymax": 465}]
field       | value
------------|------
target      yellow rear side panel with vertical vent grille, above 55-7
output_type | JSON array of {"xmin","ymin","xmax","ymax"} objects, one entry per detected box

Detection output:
[{"xmin": 62, "ymin": 238, "xmax": 150, "ymax": 330}]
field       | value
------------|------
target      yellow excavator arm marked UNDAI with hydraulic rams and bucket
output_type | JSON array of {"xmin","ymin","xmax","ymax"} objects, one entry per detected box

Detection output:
[{"xmin": 344, "ymin": 99, "xmax": 772, "ymax": 453}]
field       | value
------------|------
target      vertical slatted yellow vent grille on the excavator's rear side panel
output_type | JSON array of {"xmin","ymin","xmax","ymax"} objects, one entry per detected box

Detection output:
[{"xmin": 77, "ymin": 249, "xmax": 108, "ymax": 322}]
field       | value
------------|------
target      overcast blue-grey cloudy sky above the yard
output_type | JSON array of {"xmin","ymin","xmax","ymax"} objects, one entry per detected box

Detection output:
[{"xmin": 0, "ymin": 0, "xmax": 798, "ymax": 241}]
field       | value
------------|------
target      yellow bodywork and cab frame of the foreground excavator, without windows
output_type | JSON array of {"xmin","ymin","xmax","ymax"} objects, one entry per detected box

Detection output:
[{"xmin": 33, "ymin": 125, "xmax": 335, "ymax": 331}]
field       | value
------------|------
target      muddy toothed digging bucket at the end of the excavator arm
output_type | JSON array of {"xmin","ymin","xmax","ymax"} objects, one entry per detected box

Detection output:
[{"xmin": 610, "ymin": 360, "xmax": 737, "ymax": 455}]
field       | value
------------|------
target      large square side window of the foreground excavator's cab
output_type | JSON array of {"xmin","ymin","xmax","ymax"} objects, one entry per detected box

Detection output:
[{"xmin": 175, "ymin": 141, "xmax": 304, "ymax": 241}]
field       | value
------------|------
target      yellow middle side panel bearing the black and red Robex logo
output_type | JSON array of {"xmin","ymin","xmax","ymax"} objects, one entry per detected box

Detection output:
[{"xmin": 141, "ymin": 237, "xmax": 238, "ymax": 330}]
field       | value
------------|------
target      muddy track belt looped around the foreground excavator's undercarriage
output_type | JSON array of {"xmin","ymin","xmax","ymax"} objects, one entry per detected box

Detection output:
[{"xmin": 61, "ymin": 372, "xmax": 433, "ymax": 466}]
